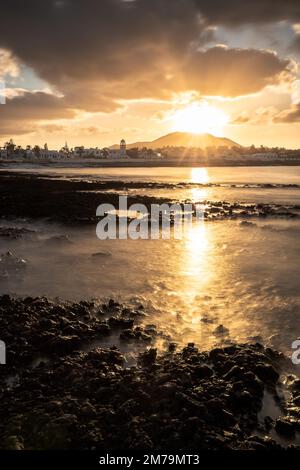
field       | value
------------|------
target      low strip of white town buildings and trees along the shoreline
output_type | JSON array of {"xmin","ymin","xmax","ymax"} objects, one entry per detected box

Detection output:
[{"xmin": 0, "ymin": 139, "xmax": 300, "ymax": 166}]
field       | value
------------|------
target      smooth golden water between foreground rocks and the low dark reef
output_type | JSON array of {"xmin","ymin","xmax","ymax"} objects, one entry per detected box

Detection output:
[{"xmin": 0, "ymin": 216, "xmax": 300, "ymax": 351}]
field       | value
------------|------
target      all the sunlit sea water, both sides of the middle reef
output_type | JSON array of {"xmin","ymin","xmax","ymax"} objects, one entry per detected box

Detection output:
[{"xmin": 0, "ymin": 167, "xmax": 300, "ymax": 355}]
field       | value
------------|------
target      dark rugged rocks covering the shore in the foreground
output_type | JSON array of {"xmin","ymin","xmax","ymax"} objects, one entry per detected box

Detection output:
[{"xmin": 0, "ymin": 296, "xmax": 300, "ymax": 451}]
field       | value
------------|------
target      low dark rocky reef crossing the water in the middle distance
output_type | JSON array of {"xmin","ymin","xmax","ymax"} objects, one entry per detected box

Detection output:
[{"xmin": 0, "ymin": 172, "xmax": 300, "ymax": 225}]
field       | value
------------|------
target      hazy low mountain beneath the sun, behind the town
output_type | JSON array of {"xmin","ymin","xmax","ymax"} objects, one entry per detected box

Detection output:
[{"xmin": 110, "ymin": 132, "xmax": 241, "ymax": 149}]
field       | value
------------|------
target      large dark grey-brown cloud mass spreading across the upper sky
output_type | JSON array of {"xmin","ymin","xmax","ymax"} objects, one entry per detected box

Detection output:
[{"xmin": 0, "ymin": 0, "xmax": 300, "ymax": 129}]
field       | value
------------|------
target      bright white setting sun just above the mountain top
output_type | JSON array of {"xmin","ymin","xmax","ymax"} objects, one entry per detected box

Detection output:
[{"xmin": 171, "ymin": 103, "xmax": 229, "ymax": 136}]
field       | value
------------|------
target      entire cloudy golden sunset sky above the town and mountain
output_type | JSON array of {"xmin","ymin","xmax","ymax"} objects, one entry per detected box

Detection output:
[{"xmin": 0, "ymin": 0, "xmax": 300, "ymax": 148}]
